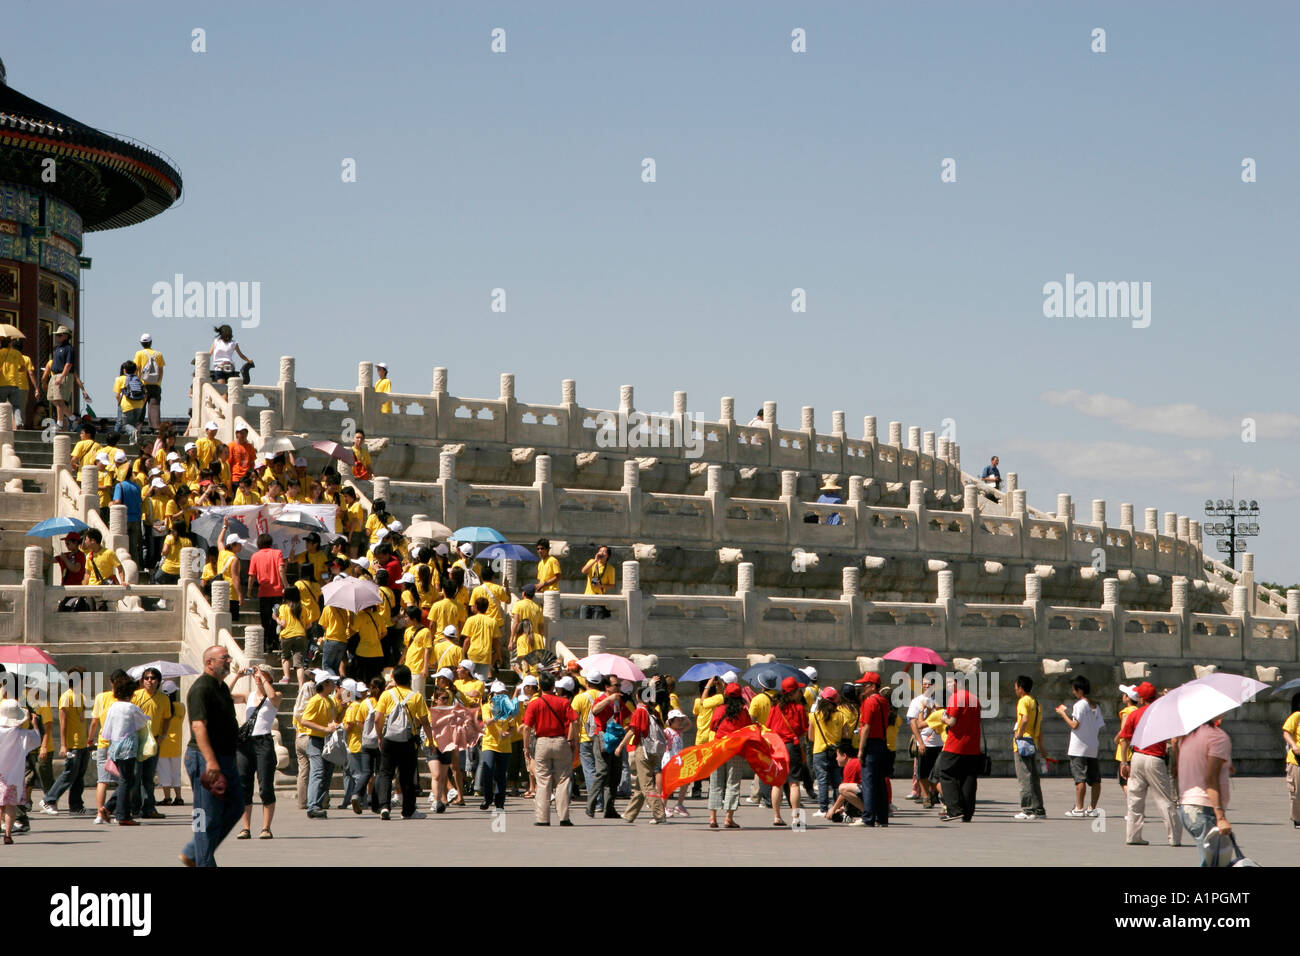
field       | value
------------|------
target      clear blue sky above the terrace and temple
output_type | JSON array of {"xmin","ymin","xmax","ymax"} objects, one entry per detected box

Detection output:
[{"xmin": 10, "ymin": 0, "xmax": 1300, "ymax": 584}]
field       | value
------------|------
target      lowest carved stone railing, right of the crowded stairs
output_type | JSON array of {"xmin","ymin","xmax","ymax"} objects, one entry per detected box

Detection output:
[{"xmin": 543, "ymin": 561, "xmax": 1300, "ymax": 665}]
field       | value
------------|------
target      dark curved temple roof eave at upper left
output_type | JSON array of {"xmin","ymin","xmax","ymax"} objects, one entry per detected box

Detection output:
[{"xmin": 0, "ymin": 61, "xmax": 181, "ymax": 232}]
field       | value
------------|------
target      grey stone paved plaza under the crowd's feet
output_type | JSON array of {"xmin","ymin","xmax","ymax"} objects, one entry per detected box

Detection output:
[{"xmin": 0, "ymin": 778, "xmax": 1300, "ymax": 868}]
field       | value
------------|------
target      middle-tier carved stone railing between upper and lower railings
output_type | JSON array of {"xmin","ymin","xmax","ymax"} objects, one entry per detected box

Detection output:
[{"xmin": 373, "ymin": 460, "xmax": 1226, "ymax": 580}]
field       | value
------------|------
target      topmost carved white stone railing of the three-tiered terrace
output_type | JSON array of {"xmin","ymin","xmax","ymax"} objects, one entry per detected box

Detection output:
[{"xmin": 190, "ymin": 352, "xmax": 963, "ymax": 494}]
